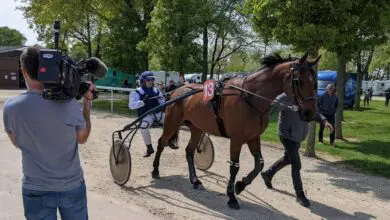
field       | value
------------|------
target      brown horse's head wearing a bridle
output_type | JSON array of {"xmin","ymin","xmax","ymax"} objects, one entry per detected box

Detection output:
[{"xmin": 283, "ymin": 53, "xmax": 321, "ymax": 121}]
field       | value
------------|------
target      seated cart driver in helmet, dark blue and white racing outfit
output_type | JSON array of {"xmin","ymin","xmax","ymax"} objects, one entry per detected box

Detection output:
[{"xmin": 129, "ymin": 71, "xmax": 179, "ymax": 157}]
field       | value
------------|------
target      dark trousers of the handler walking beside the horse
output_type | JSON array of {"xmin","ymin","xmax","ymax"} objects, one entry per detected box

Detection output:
[{"xmin": 266, "ymin": 137, "xmax": 303, "ymax": 193}]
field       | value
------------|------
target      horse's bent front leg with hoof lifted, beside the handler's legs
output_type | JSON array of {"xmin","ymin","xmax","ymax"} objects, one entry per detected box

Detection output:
[{"xmin": 235, "ymin": 137, "xmax": 264, "ymax": 195}]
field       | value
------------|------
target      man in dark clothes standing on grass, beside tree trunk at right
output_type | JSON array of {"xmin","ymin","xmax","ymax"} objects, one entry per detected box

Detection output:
[{"xmin": 318, "ymin": 83, "xmax": 339, "ymax": 145}]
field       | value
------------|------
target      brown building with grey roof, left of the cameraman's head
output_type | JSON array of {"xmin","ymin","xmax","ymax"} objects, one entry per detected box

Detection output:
[{"xmin": 0, "ymin": 46, "xmax": 26, "ymax": 89}]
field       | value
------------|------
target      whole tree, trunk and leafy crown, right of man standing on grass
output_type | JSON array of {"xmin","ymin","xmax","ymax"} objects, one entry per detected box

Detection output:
[{"xmin": 325, "ymin": 0, "xmax": 389, "ymax": 139}]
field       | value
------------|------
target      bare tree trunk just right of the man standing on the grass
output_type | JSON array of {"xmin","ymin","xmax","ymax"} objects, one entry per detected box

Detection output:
[{"xmin": 335, "ymin": 52, "xmax": 346, "ymax": 139}]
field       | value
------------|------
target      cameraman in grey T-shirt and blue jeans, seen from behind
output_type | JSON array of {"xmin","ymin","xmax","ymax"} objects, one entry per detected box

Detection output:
[{"xmin": 3, "ymin": 47, "xmax": 95, "ymax": 220}]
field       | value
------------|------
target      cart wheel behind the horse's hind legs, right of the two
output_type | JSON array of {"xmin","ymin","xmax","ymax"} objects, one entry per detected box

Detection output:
[{"xmin": 194, "ymin": 134, "xmax": 214, "ymax": 171}]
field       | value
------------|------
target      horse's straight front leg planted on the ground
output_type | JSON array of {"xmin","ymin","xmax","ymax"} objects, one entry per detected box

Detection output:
[{"xmin": 226, "ymin": 140, "xmax": 242, "ymax": 209}]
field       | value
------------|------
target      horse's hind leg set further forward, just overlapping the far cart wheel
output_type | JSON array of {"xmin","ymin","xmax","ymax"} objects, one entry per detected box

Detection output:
[{"xmin": 186, "ymin": 124, "xmax": 203, "ymax": 189}]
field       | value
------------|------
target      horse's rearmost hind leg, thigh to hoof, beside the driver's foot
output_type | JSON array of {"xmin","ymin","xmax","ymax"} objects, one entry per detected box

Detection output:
[{"xmin": 152, "ymin": 106, "xmax": 182, "ymax": 179}]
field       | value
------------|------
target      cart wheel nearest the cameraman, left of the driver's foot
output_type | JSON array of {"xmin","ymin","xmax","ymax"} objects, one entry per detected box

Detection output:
[{"xmin": 110, "ymin": 140, "xmax": 131, "ymax": 186}]
